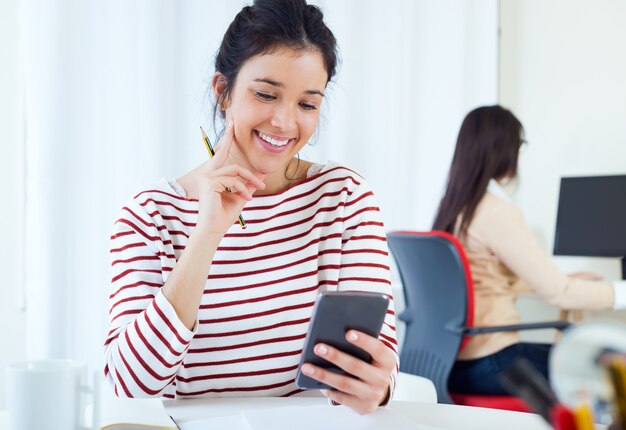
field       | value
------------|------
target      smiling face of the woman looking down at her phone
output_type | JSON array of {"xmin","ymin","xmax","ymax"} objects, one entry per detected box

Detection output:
[{"xmin": 214, "ymin": 47, "xmax": 328, "ymax": 190}]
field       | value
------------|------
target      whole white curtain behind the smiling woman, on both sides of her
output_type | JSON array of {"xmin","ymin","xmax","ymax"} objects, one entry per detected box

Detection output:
[{"xmin": 14, "ymin": 0, "xmax": 498, "ymax": 369}]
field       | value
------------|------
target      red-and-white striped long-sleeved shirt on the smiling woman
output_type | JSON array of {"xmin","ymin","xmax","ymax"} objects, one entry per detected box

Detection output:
[{"xmin": 105, "ymin": 163, "xmax": 398, "ymax": 398}]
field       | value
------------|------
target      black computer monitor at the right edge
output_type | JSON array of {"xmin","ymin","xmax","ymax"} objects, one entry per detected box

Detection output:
[{"xmin": 554, "ymin": 175, "xmax": 626, "ymax": 279}]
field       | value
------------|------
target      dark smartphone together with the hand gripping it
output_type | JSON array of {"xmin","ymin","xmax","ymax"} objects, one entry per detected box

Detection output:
[{"xmin": 296, "ymin": 291, "xmax": 396, "ymax": 414}]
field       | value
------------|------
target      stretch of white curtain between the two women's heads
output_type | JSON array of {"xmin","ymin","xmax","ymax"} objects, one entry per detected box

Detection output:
[{"xmin": 303, "ymin": 0, "xmax": 498, "ymax": 230}]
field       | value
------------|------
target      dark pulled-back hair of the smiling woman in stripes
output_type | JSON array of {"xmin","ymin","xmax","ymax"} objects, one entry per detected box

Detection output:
[{"xmin": 215, "ymin": 0, "xmax": 337, "ymax": 116}]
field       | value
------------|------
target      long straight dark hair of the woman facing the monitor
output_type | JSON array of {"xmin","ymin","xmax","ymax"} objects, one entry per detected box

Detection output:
[{"xmin": 433, "ymin": 105, "xmax": 524, "ymax": 236}]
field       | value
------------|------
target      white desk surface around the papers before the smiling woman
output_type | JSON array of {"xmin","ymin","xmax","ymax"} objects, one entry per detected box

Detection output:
[{"xmin": 163, "ymin": 397, "xmax": 550, "ymax": 430}]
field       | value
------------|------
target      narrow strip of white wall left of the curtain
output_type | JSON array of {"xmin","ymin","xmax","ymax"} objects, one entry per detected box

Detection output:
[{"xmin": 0, "ymin": 0, "xmax": 25, "ymax": 410}]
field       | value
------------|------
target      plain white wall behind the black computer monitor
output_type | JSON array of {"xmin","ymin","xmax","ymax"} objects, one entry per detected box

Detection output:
[{"xmin": 500, "ymin": 0, "xmax": 626, "ymax": 339}]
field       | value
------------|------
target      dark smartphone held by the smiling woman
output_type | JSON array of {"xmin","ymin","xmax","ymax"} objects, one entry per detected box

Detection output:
[{"xmin": 296, "ymin": 291, "xmax": 389, "ymax": 390}]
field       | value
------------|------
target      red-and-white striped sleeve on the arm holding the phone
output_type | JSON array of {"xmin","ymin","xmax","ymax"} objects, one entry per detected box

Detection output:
[{"xmin": 339, "ymin": 178, "xmax": 399, "ymax": 402}]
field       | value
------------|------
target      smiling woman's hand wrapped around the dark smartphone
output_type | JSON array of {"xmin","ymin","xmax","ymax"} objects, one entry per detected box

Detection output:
[{"xmin": 302, "ymin": 330, "xmax": 396, "ymax": 414}]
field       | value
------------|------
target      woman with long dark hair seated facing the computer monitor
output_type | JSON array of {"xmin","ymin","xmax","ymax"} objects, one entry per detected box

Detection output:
[{"xmin": 433, "ymin": 106, "xmax": 626, "ymax": 395}]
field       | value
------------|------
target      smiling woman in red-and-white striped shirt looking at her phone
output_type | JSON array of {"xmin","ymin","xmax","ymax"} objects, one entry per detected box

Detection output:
[{"xmin": 105, "ymin": 0, "xmax": 398, "ymax": 413}]
